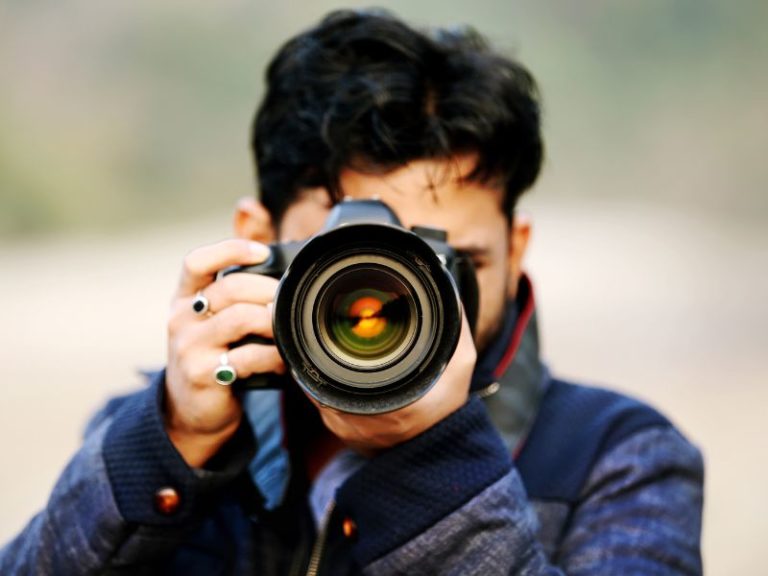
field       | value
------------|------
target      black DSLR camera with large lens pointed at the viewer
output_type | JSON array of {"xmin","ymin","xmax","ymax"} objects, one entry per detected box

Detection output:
[{"xmin": 219, "ymin": 200, "xmax": 478, "ymax": 414}]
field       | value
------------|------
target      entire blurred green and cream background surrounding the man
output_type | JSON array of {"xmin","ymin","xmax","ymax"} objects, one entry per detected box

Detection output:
[{"xmin": 0, "ymin": 0, "xmax": 768, "ymax": 575}]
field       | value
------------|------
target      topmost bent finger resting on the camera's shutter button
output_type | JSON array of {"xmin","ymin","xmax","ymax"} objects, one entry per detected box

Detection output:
[{"xmin": 179, "ymin": 238, "xmax": 269, "ymax": 296}]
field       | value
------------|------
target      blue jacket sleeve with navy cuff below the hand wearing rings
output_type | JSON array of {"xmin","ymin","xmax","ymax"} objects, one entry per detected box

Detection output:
[{"xmin": 0, "ymin": 373, "xmax": 253, "ymax": 576}]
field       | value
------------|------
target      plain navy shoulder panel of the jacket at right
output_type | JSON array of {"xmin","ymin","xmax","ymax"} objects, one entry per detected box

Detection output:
[{"xmin": 516, "ymin": 380, "xmax": 695, "ymax": 502}]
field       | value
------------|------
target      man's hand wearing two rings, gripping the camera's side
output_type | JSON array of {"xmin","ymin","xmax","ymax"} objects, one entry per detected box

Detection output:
[{"xmin": 165, "ymin": 239, "xmax": 285, "ymax": 467}]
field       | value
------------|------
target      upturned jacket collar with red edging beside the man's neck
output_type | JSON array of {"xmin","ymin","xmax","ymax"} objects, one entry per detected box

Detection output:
[{"xmin": 471, "ymin": 275, "xmax": 549, "ymax": 454}]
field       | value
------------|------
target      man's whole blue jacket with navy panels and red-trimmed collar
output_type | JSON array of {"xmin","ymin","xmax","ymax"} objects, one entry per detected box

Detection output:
[{"xmin": 0, "ymin": 281, "xmax": 703, "ymax": 576}]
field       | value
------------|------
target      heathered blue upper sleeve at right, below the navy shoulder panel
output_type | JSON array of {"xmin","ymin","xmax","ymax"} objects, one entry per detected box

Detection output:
[{"xmin": 557, "ymin": 427, "xmax": 704, "ymax": 576}]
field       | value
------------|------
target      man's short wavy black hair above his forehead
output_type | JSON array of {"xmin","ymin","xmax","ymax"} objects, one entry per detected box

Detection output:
[{"xmin": 252, "ymin": 10, "xmax": 543, "ymax": 222}]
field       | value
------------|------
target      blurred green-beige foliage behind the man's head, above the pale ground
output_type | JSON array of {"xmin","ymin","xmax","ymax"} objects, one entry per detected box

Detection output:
[{"xmin": 0, "ymin": 0, "xmax": 768, "ymax": 238}]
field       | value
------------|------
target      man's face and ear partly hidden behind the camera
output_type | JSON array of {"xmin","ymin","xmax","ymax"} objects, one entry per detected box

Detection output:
[{"xmin": 278, "ymin": 155, "xmax": 527, "ymax": 350}]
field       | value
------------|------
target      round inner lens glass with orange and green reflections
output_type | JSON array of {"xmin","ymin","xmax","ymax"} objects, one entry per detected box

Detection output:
[{"xmin": 317, "ymin": 266, "xmax": 418, "ymax": 370}]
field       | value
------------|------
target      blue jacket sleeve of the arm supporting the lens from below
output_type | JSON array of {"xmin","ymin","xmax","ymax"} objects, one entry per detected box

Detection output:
[{"xmin": 337, "ymin": 400, "xmax": 702, "ymax": 575}]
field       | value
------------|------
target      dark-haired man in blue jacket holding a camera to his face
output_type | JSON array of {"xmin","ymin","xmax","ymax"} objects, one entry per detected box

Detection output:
[{"xmin": 0, "ymin": 12, "xmax": 703, "ymax": 575}]
